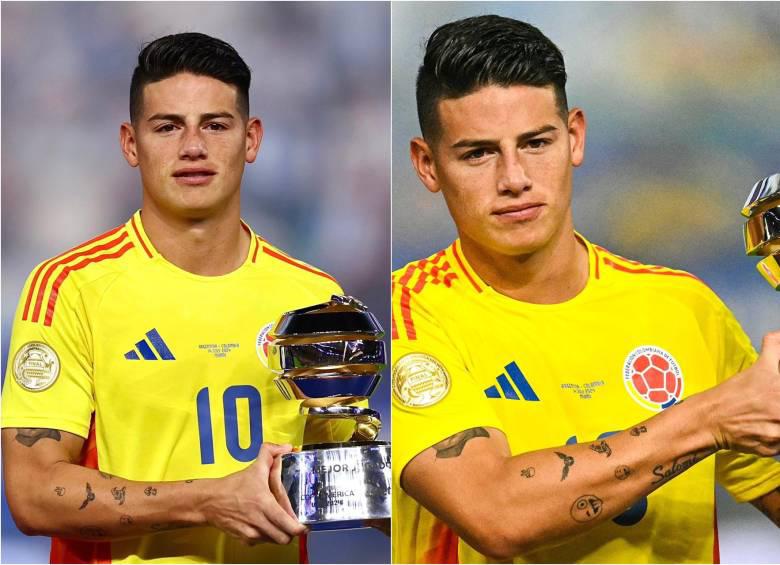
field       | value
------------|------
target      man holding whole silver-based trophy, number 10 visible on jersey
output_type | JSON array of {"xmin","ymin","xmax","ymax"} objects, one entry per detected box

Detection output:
[{"xmin": 2, "ymin": 33, "xmax": 340, "ymax": 563}]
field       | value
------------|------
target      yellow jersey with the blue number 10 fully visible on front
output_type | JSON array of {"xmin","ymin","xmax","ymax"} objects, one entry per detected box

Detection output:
[{"xmin": 2, "ymin": 212, "xmax": 341, "ymax": 563}]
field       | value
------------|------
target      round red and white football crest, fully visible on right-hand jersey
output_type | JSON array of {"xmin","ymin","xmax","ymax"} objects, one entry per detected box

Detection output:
[{"xmin": 623, "ymin": 345, "xmax": 683, "ymax": 412}]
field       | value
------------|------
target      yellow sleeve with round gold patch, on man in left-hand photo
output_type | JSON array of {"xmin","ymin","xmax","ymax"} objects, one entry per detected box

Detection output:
[{"xmin": 0, "ymin": 263, "xmax": 94, "ymax": 438}]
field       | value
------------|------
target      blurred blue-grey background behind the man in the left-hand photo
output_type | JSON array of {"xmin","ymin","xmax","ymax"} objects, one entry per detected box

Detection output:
[{"xmin": 0, "ymin": 2, "xmax": 390, "ymax": 563}]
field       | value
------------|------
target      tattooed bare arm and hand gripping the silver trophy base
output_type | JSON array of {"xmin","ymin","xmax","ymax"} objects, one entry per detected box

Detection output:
[{"xmin": 2, "ymin": 428, "xmax": 305, "ymax": 544}]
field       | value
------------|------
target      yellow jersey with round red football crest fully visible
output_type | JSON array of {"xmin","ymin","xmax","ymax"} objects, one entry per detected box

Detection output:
[{"xmin": 392, "ymin": 236, "xmax": 780, "ymax": 563}]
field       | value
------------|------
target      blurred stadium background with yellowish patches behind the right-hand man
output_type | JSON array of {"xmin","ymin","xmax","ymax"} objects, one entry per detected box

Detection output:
[{"xmin": 392, "ymin": 2, "xmax": 780, "ymax": 563}]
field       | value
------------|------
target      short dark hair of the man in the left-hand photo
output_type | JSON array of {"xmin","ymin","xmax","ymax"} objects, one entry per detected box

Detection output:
[{"xmin": 130, "ymin": 33, "xmax": 252, "ymax": 122}]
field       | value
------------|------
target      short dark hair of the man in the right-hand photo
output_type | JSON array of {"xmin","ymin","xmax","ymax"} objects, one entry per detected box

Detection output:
[{"xmin": 417, "ymin": 15, "xmax": 569, "ymax": 141}]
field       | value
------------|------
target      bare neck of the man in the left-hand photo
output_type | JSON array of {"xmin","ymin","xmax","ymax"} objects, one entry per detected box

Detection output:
[{"xmin": 141, "ymin": 202, "xmax": 251, "ymax": 276}]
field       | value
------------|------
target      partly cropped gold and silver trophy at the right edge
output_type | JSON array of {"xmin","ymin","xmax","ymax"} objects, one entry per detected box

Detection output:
[{"xmin": 742, "ymin": 173, "xmax": 780, "ymax": 290}]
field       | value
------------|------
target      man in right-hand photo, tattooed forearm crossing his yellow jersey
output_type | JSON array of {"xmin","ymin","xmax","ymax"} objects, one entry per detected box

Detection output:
[{"xmin": 393, "ymin": 16, "xmax": 780, "ymax": 563}]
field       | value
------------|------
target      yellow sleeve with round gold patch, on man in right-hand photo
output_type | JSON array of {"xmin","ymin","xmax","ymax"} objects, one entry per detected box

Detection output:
[{"xmin": 392, "ymin": 285, "xmax": 502, "ymax": 476}]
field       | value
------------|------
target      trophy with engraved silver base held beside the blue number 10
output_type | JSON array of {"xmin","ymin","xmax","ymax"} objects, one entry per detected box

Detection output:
[{"xmin": 268, "ymin": 295, "xmax": 391, "ymax": 530}]
